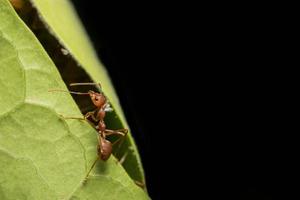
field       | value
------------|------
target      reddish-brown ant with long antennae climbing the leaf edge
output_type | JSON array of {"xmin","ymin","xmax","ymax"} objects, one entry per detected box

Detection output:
[{"xmin": 51, "ymin": 83, "xmax": 128, "ymax": 179}]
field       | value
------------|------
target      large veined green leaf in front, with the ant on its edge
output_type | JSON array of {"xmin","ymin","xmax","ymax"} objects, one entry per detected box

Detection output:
[{"xmin": 0, "ymin": 0, "xmax": 148, "ymax": 200}]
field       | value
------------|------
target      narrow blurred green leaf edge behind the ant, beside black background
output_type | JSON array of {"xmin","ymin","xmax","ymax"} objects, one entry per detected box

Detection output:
[{"xmin": 31, "ymin": 0, "xmax": 145, "ymax": 182}]
